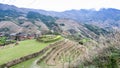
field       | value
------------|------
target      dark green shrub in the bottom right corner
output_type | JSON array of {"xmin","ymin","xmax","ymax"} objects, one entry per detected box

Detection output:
[{"xmin": 87, "ymin": 48, "xmax": 120, "ymax": 68}]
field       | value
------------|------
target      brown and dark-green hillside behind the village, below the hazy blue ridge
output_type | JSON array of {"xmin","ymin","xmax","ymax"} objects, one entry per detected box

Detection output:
[{"xmin": 0, "ymin": 4, "xmax": 108, "ymax": 40}]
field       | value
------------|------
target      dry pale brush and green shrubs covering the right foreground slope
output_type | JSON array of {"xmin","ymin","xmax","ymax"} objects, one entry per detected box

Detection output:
[{"xmin": 80, "ymin": 33, "xmax": 120, "ymax": 68}]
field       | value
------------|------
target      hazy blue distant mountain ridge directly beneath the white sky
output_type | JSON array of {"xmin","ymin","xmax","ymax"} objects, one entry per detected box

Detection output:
[{"xmin": 0, "ymin": 4, "xmax": 120, "ymax": 29}]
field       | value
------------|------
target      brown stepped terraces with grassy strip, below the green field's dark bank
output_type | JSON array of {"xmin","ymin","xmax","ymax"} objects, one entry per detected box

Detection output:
[{"xmin": 11, "ymin": 39, "xmax": 85, "ymax": 68}]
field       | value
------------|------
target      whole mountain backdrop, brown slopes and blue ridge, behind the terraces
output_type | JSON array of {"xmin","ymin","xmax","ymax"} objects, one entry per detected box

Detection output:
[{"xmin": 0, "ymin": 4, "xmax": 120, "ymax": 37}]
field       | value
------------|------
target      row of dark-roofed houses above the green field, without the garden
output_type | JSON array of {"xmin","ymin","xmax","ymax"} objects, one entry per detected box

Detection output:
[{"xmin": 0, "ymin": 32, "xmax": 41, "ymax": 41}]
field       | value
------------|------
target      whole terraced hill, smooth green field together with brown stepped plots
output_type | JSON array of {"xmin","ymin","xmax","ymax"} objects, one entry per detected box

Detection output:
[{"xmin": 1, "ymin": 35, "xmax": 86, "ymax": 68}]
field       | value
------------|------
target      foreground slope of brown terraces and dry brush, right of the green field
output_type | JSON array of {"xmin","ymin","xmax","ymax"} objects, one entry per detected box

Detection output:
[{"xmin": 7, "ymin": 33, "xmax": 120, "ymax": 68}]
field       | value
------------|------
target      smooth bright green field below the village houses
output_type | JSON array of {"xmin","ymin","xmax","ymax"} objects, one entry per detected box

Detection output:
[{"xmin": 0, "ymin": 39, "xmax": 52, "ymax": 65}]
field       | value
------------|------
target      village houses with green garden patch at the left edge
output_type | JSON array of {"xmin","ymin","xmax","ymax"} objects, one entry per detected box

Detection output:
[{"xmin": 0, "ymin": 32, "xmax": 41, "ymax": 46}]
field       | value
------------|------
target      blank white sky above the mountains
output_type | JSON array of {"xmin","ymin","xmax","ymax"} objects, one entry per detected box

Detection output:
[{"xmin": 0, "ymin": 0, "xmax": 120, "ymax": 12}]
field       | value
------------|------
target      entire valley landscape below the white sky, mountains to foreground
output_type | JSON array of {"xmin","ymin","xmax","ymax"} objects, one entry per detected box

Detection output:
[{"xmin": 0, "ymin": 4, "xmax": 120, "ymax": 68}]
